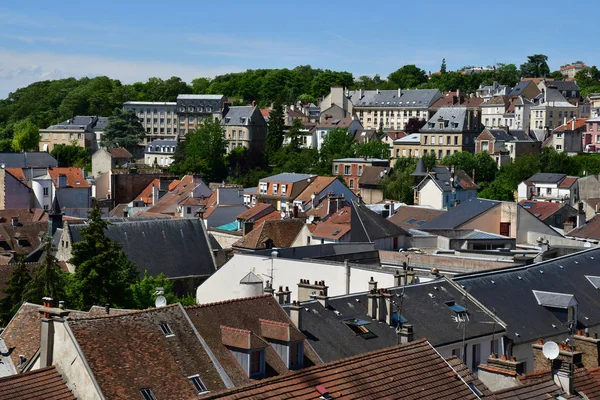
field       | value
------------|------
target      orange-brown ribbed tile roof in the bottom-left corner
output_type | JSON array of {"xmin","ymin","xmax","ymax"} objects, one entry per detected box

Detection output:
[{"xmin": 0, "ymin": 366, "xmax": 75, "ymax": 400}]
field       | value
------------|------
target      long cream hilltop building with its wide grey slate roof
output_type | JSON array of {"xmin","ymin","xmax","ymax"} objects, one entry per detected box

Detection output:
[{"xmin": 348, "ymin": 89, "xmax": 442, "ymax": 131}]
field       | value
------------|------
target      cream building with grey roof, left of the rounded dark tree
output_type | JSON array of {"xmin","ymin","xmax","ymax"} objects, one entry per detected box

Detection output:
[{"xmin": 39, "ymin": 115, "xmax": 107, "ymax": 152}]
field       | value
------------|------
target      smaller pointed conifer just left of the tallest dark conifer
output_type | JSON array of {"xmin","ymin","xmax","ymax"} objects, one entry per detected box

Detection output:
[{"xmin": 23, "ymin": 235, "xmax": 69, "ymax": 303}]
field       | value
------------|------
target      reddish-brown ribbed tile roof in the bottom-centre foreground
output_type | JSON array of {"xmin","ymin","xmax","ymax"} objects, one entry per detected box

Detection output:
[{"xmin": 202, "ymin": 340, "xmax": 477, "ymax": 400}]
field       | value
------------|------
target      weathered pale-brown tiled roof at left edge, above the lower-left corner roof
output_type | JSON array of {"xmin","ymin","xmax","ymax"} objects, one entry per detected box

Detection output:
[{"xmin": 0, "ymin": 303, "xmax": 87, "ymax": 367}]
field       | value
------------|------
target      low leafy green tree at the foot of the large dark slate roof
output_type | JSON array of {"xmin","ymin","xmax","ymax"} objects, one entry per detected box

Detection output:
[{"xmin": 129, "ymin": 271, "xmax": 196, "ymax": 310}]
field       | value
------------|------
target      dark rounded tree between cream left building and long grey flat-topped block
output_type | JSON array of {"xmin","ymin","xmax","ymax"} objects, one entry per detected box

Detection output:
[{"xmin": 100, "ymin": 108, "xmax": 146, "ymax": 150}]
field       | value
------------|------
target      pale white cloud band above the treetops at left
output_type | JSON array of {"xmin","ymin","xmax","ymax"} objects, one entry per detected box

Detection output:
[{"xmin": 0, "ymin": 49, "xmax": 243, "ymax": 98}]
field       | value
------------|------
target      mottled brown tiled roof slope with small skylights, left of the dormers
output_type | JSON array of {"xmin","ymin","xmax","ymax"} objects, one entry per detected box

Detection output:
[{"xmin": 68, "ymin": 304, "xmax": 226, "ymax": 399}]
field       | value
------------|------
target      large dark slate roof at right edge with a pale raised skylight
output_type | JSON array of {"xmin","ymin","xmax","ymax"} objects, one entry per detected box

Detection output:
[{"xmin": 454, "ymin": 247, "xmax": 600, "ymax": 343}]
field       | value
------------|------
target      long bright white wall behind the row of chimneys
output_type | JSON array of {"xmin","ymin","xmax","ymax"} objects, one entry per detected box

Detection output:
[{"xmin": 196, "ymin": 253, "xmax": 394, "ymax": 304}]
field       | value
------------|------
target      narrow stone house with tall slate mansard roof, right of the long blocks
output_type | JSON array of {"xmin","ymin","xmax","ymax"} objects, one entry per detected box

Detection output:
[{"xmin": 221, "ymin": 103, "xmax": 267, "ymax": 152}]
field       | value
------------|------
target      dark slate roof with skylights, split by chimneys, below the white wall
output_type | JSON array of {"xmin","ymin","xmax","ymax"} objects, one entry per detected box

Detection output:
[{"xmin": 284, "ymin": 278, "xmax": 504, "ymax": 362}]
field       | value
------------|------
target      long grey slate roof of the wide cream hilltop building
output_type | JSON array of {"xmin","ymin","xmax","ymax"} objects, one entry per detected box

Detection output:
[{"xmin": 348, "ymin": 89, "xmax": 442, "ymax": 108}]
